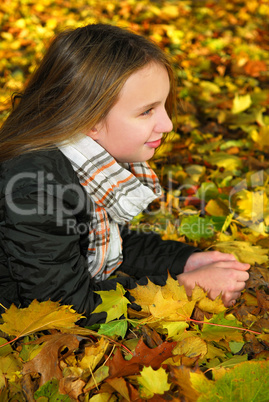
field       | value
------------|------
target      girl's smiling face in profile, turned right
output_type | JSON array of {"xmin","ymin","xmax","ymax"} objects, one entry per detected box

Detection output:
[{"xmin": 87, "ymin": 63, "xmax": 173, "ymax": 162}]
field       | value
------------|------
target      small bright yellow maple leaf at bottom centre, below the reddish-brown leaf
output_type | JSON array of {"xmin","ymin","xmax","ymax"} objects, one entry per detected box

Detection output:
[{"xmin": 137, "ymin": 367, "xmax": 171, "ymax": 398}]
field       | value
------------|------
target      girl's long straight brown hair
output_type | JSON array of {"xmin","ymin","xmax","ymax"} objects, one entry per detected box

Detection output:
[{"xmin": 0, "ymin": 24, "xmax": 176, "ymax": 161}]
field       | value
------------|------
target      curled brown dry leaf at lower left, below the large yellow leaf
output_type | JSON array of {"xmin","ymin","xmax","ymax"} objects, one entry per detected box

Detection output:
[{"xmin": 22, "ymin": 334, "xmax": 79, "ymax": 385}]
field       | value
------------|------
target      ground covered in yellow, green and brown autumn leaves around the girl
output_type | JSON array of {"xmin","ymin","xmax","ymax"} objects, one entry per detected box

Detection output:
[{"xmin": 0, "ymin": 0, "xmax": 269, "ymax": 402}]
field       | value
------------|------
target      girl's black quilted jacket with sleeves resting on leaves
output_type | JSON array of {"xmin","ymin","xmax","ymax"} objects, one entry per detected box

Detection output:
[{"xmin": 0, "ymin": 149, "xmax": 197, "ymax": 325}]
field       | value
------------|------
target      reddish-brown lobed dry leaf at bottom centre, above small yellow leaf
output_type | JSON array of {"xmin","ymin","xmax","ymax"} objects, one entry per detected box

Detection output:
[{"xmin": 106, "ymin": 339, "xmax": 176, "ymax": 378}]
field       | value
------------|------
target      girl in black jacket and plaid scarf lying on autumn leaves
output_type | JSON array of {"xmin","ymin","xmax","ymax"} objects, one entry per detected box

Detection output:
[{"xmin": 0, "ymin": 24, "xmax": 249, "ymax": 325}]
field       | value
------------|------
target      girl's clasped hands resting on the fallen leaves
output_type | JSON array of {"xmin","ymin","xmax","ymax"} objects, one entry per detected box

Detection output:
[{"xmin": 177, "ymin": 252, "xmax": 250, "ymax": 307}]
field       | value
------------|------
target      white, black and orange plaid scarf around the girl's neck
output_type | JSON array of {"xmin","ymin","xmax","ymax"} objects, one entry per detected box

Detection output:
[{"xmin": 59, "ymin": 135, "xmax": 162, "ymax": 281}]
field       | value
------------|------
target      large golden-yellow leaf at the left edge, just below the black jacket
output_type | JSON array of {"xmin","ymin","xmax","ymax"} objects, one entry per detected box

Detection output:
[{"xmin": 0, "ymin": 300, "xmax": 83, "ymax": 338}]
